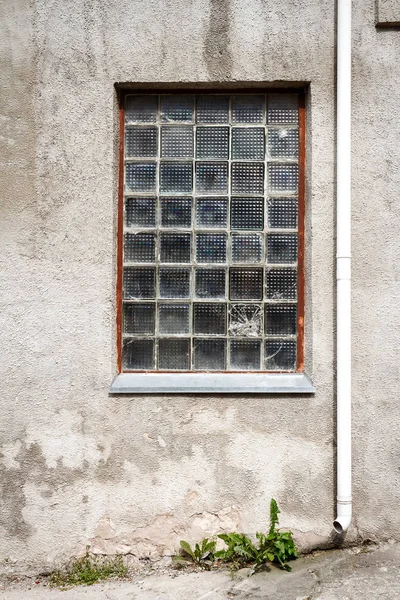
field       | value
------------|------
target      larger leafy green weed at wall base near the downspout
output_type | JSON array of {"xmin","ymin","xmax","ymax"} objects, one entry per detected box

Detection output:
[{"xmin": 174, "ymin": 498, "xmax": 297, "ymax": 575}]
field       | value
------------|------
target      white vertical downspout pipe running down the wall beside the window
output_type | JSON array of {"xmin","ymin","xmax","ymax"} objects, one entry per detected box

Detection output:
[{"xmin": 333, "ymin": 0, "xmax": 352, "ymax": 533}]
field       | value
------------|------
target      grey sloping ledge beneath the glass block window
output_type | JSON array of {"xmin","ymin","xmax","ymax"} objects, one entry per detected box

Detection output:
[{"xmin": 110, "ymin": 373, "xmax": 315, "ymax": 394}]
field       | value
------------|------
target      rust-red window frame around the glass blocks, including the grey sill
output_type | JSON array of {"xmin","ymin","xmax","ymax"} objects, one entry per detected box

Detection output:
[{"xmin": 110, "ymin": 87, "xmax": 315, "ymax": 393}]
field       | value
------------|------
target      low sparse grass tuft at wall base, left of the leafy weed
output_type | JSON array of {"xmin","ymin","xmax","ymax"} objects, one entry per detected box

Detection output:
[{"xmin": 50, "ymin": 549, "xmax": 128, "ymax": 588}]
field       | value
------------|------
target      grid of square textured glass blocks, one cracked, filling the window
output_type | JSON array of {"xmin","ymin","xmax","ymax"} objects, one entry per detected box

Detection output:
[{"xmin": 119, "ymin": 91, "xmax": 304, "ymax": 372}]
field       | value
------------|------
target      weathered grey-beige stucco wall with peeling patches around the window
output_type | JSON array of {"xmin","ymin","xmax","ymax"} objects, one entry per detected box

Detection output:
[{"xmin": 0, "ymin": 0, "xmax": 400, "ymax": 562}]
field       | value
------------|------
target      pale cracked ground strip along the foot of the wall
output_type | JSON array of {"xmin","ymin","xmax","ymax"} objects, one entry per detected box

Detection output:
[{"xmin": 0, "ymin": 543, "xmax": 400, "ymax": 600}]
